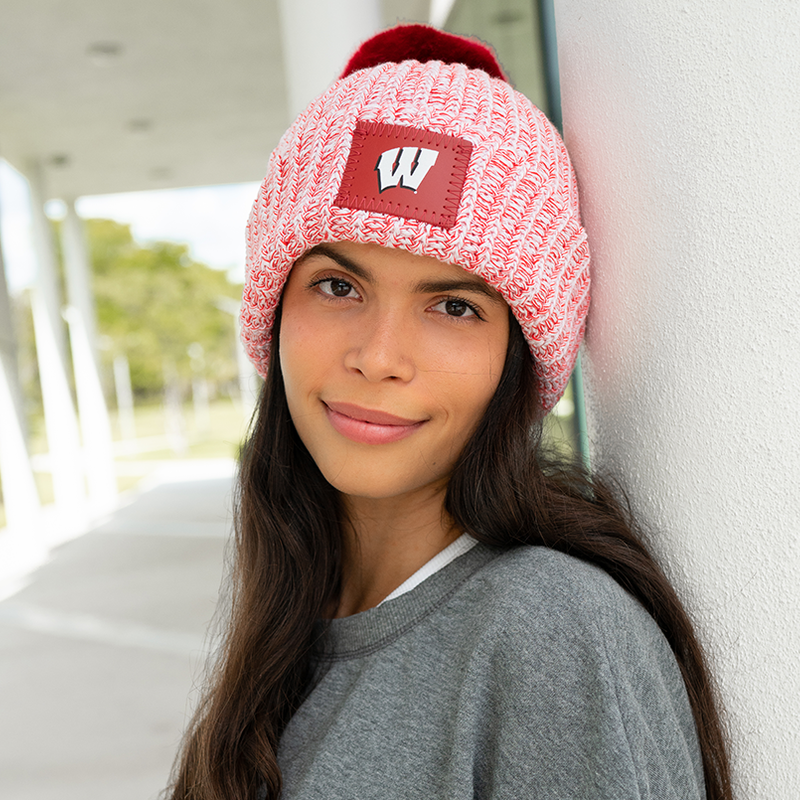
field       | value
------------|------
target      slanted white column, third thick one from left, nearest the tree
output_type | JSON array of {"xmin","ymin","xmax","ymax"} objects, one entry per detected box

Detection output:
[{"xmin": 61, "ymin": 200, "xmax": 117, "ymax": 513}]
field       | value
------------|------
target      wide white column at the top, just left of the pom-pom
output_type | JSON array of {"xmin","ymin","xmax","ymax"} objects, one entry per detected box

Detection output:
[{"xmin": 278, "ymin": 0, "xmax": 381, "ymax": 119}]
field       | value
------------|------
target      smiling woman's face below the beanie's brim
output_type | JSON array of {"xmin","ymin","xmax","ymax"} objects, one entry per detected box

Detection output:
[{"xmin": 280, "ymin": 242, "xmax": 509, "ymax": 498}]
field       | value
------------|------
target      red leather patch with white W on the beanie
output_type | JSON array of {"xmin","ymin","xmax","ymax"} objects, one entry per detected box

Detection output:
[{"xmin": 333, "ymin": 121, "xmax": 472, "ymax": 228}]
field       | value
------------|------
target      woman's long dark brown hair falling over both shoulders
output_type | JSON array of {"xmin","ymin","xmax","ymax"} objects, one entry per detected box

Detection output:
[{"xmin": 167, "ymin": 310, "xmax": 731, "ymax": 800}]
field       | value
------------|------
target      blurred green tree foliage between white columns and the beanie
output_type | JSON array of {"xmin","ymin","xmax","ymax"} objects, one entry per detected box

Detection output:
[{"xmin": 86, "ymin": 219, "xmax": 241, "ymax": 396}]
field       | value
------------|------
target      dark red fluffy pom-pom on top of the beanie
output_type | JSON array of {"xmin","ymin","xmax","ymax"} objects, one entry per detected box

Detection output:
[{"xmin": 339, "ymin": 25, "xmax": 508, "ymax": 81}]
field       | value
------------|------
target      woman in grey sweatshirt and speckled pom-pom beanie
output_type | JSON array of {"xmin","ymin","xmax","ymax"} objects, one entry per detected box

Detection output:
[{"xmin": 171, "ymin": 21, "xmax": 730, "ymax": 800}]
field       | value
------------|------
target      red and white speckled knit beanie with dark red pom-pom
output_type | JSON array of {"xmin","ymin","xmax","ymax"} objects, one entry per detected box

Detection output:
[{"xmin": 241, "ymin": 25, "xmax": 589, "ymax": 411}]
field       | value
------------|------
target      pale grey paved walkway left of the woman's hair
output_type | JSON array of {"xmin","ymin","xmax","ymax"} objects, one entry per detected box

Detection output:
[{"xmin": 0, "ymin": 468, "xmax": 231, "ymax": 800}]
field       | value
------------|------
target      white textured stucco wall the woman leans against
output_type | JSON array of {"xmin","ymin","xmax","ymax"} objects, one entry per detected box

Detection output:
[{"xmin": 556, "ymin": 0, "xmax": 800, "ymax": 800}]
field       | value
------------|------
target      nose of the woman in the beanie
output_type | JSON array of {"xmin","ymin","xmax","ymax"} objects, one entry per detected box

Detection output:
[{"xmin": 345, "ymin": 311, "xmax": 414, "ymax": 382}]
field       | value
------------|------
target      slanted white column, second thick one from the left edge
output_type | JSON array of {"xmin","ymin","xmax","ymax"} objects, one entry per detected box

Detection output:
[{"xmin": 28, "ymin": 167, "xmax": 86, "ymax": 527}]
